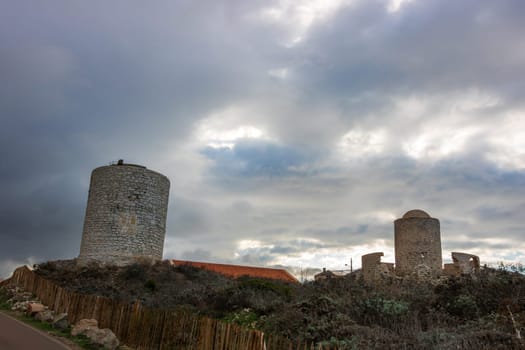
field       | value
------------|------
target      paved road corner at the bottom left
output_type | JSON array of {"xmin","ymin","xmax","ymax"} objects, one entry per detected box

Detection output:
[{"xmin": 0, "ymin": 312, "xmax": 69, "ymax": 350}]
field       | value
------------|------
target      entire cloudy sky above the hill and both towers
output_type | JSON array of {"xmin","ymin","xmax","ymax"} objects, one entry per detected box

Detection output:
[{"xmin": 0, "ymin": 0, "xmax": 525, "ymax": 277}]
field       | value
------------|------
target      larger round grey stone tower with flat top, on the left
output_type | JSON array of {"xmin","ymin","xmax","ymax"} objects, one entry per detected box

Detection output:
[{"xmin": 78, "ymin": 160, "xmax": 170, "ymax": 265}]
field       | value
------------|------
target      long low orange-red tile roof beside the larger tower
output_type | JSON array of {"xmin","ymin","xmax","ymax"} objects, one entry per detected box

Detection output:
[{"xmin": 170, "ymin": 260, "xmax": 298, "ymax": 283}]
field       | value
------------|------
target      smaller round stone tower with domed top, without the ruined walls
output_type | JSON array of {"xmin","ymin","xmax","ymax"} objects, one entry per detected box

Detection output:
[{"xmin": 394, "ymin": 209, "xmax": 443, "ymax": 276}]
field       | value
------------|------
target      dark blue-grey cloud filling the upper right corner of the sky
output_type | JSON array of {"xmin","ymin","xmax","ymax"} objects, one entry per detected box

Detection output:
[{"xmin": 292, "ymin": 0, "xmax": 525, "ymax": 96}]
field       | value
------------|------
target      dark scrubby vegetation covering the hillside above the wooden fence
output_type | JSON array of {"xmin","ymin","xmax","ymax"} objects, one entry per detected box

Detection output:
[{"xmin": 33, "ymin": 261, "xmax": 525, "ymax": 349}]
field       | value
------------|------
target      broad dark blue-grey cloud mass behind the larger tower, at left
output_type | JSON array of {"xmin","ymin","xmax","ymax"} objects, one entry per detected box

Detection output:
[{"xmin": 0, "ymin": 1, "xmax": 278, "ymax": 274}]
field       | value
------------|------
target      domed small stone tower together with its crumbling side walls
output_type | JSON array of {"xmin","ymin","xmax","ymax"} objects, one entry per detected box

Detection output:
[{"xmin": 361, "ymin": 209, "xmax": 480, "ymax": 282}]
